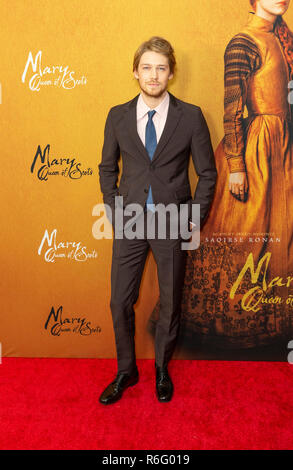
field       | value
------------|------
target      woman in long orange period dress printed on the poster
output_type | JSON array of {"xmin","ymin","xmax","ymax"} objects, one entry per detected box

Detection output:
[{"xmin": 149, "ymin": 0, "xmax": 293, "ymax": 348}]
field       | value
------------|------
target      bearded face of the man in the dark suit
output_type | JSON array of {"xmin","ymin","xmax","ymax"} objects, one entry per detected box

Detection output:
[{"xmin": 134, "ymin": 51, "xmax": 173, "ymax": 98}]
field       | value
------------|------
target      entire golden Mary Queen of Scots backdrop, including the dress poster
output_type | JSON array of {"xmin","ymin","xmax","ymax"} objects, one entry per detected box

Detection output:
[{"xmin": 0, "ymin": 0, "xmax": 293, "ymax": 360}]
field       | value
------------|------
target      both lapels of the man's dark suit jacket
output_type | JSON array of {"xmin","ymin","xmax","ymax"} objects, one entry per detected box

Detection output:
[{"xmin": 124, "ymin": 93, "xmax": 182, "ymax": 162}]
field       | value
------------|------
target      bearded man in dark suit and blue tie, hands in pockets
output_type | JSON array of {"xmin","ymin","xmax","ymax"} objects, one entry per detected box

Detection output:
[{"xmin": 99, "ymin": 37, "xmax": 217, "ymax": 404}]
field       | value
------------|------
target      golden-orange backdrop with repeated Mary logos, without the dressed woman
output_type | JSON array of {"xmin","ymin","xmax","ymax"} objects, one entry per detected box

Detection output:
[{"xmin": 0, "ymin": 0, "xmax": 293, "ymax": 358}]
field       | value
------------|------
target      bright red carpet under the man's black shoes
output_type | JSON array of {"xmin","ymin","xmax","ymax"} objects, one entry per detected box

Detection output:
[{"xmin": 0, "ymin": 358, "xmax": 293, "ymax": 450}]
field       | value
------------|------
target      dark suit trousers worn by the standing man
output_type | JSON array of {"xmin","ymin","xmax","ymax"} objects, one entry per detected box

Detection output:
[{"xmin": 110, "ymin": 210, "xmax": 187, "ymax": 374}]
